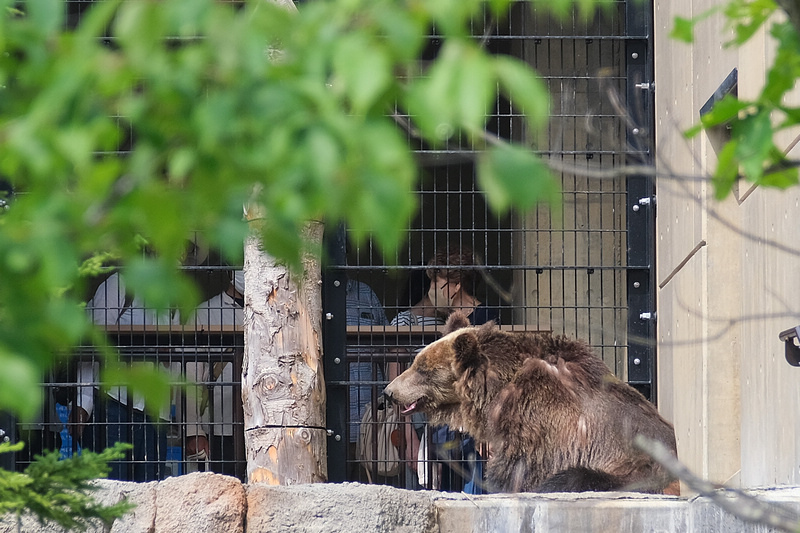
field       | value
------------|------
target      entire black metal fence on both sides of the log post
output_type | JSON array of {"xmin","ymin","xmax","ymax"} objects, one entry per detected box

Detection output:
[{"xmin": 7, "ymin": 0, "xmax": 655, "ymax": 492}]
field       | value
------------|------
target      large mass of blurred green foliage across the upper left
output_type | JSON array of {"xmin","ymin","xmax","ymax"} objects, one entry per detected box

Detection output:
[{"xmin": 0, "ymin": 0, "xmax": 592, "ymax": 418}]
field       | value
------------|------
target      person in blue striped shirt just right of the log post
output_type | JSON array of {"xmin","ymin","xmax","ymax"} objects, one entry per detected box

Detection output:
[{"xmin": 345, "ymin": 278, "xmax": 389, "ymax": 480}]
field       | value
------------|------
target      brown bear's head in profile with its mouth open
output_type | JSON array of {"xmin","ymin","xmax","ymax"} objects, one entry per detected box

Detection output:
[{"xmin": 384, "ymin": 312, "xmax": 484, "ymax": 418}]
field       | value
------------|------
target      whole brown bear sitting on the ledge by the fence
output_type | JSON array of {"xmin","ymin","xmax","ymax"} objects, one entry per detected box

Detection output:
[{"xmin": 384, "ymin": 313, "xmax": 678, "ymax": 494}]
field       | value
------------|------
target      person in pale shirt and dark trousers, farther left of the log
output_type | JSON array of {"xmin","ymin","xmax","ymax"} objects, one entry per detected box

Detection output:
[{"xmin": 70, "ymin": 272, "xmax": 172, "ymax": 482}]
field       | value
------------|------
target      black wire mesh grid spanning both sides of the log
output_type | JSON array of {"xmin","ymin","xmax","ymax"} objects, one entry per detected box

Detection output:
[{"xmin": 12, "ymin": 0, "xmax": 648, "ymax": 490}]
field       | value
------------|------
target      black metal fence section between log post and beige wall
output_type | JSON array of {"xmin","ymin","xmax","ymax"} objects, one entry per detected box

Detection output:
[{"xmin": 325, "ymin": 1, "xmax": 655, "ymax": 492}]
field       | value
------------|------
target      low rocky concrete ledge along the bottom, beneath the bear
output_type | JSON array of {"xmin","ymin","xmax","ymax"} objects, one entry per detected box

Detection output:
[{"xmin": 0, "ymin": 473, "xmax": 800, "ymax": 533}]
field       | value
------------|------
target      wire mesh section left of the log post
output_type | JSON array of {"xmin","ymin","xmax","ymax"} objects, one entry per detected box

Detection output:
[{"xmin": 16, "ymin": 233, "xmax": 246, "ymax": 481}]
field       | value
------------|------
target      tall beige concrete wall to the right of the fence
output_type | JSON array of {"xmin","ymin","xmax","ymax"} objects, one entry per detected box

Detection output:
[{"xmin": 654, "ymin": 0, "xmax": 800, "ymax": 487}]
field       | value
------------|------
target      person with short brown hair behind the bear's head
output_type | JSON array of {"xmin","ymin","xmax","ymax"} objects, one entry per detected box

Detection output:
[{"xmin": 426, "ymin": 245, "xmax": 499, "ymax": 494}]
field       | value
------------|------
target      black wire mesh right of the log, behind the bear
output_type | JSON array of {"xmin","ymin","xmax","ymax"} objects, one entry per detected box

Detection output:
[{"xmin": 338, "ymin": 1, "xmax": 635, "ymax": 493}]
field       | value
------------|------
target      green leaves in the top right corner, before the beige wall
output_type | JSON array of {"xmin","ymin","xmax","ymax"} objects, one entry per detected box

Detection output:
[{"xmin": 671, "ymin": 0, "xmax": 800, "ymax": 199}]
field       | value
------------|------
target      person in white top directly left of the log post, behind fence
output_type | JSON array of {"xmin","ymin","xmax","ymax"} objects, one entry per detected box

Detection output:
[{"xmin": 185, "ymin": 270, "xmax": 244, "ymax": 478}]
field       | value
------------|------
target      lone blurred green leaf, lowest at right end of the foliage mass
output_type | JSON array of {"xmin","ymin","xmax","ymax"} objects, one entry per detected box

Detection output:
[{"xmin": 478, "ymin": 145, "xmax": 560, "ymax": 213}]
